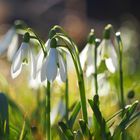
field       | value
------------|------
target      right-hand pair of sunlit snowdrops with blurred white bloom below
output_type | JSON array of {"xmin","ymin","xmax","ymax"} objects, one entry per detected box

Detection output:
[{"xmin": 80, "ymin": 25, "xmax": 118, "ymax": 95}]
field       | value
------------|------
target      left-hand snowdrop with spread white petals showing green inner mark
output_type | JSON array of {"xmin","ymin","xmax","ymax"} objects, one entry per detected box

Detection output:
[{"xmin": 11, "ymin": 33, "xmax": 35, "ymax": 78}]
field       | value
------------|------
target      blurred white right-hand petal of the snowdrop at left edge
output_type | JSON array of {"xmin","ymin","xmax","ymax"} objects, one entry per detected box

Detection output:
[{"xmin": 7, "ymin": 34, "xmax": 18, "ymax": 61}]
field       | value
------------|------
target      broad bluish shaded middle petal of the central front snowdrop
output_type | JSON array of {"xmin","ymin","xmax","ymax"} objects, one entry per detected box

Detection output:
[{"xmin": 46, "ymin": 48, "xmax": 58, "ymax": 82}]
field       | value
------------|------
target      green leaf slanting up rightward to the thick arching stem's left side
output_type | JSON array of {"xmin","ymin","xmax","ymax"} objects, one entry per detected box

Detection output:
[{"xmin": 68, "ymin": 102, "xmax": 81, "ymax": 128}]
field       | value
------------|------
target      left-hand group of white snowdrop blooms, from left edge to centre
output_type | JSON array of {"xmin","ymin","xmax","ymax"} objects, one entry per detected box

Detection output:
[{"xmin": 0, "ymin": 28, "xmax": 67, "ymax": 87}]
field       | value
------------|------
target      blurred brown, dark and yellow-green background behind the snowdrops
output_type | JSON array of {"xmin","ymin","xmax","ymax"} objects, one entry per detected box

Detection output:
[{"xmin": 0, "ymin": 0, "xmax": 140, "ymax": 140}]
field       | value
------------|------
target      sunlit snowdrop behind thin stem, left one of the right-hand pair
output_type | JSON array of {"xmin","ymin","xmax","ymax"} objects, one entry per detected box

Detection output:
[{"xmin": 80, "ymin": 29, "xmax": 100, "ymax": 77}]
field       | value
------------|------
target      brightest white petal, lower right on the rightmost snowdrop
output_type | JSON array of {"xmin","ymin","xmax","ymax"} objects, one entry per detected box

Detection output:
[{"xmin": 105, "ymin": 58, "xmax": 115, "ymax": 73}]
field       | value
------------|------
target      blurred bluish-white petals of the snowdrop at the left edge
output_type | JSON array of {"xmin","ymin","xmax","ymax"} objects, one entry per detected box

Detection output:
[{"xmin": 0, "ymin": 27, "xmax": 18, "ymax": 61}]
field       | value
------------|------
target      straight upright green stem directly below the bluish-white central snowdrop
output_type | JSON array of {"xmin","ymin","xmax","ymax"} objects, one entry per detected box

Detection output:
[{"xmin": 46, "ymin": 81, "xmax": 51, "ymax": 140}]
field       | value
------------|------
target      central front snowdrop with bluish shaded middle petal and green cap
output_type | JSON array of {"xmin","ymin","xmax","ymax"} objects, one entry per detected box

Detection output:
[{"xmin": 41, "ymin": 39, "xmax": 66, "ymax": 82}]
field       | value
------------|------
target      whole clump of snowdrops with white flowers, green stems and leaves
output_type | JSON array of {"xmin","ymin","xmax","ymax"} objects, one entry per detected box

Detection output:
[{"xmin": 0, "ymin": 21, "xmax": 140, "ymax": 140}]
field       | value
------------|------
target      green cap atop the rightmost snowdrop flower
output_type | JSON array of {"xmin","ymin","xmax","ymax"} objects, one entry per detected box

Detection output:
[{"xmin": 103, "ymin": 24, "xmax": 112, "ymax": 39}]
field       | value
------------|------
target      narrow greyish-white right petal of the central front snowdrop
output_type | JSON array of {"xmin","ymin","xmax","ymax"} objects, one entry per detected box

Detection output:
[{"xmin": 58, "ymin": 54, "xmax": 67, "ymax": 82}]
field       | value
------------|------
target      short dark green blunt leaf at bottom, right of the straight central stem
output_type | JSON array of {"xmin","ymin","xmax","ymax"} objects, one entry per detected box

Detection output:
[{"xmin": 58, "ymin": 122, "xmax": 74, "ymax": 140}]
